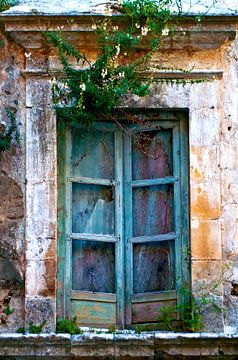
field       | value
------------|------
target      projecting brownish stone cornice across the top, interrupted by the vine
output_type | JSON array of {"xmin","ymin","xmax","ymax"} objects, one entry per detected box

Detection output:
[{"xmin": 0, "ymin": 15, "xmax": 236, "ymax": 51}]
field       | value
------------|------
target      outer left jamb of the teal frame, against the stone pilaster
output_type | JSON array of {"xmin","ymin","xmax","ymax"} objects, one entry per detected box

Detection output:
[{"xmin": 57, "ymin": 121, "xmax": 66, "ymax": 317}]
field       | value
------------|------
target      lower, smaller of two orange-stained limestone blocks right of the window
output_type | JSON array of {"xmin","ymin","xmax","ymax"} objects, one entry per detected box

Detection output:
[{"xmin": 191, "ymin": 220, "xmax": 222, "ymax": 260}]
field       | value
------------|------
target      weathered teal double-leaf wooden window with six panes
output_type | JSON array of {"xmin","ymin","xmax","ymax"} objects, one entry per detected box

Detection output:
[{"xmin": 58, "ymin": 114, "xmax": 188, "ymax": 327}]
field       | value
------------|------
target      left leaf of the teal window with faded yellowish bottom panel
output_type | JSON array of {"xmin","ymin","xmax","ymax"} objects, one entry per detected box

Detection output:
[{"xmin": 67, "ymin": 123, "xmax": 117, "ymax": 326}]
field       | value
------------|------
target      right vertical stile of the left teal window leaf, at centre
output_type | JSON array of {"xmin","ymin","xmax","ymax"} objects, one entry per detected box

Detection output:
[{"xmin": 115, "ymin": 128, "xmax": 125, "ymax": 328}]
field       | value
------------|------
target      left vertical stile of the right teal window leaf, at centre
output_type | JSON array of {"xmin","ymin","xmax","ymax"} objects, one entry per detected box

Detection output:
[{"xmin": 124, "ymin": 134, "xmax": 133, "ymax": 325}]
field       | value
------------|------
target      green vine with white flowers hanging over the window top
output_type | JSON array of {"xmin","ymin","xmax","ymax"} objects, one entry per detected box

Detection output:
[{"xmin": 45, "ymin": 0, "xmax": 184, "ymax": 128}]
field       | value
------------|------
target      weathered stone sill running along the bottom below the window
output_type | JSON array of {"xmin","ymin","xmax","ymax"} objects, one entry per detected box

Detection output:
[{"xmin": 0, "ymin": 332, "xmax": 238, "ymax": 360}]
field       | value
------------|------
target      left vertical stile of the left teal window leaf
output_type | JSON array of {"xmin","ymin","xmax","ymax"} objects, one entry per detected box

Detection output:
[{"xmin": 65, "ymin": 129, "xmax": 72, "ymax": 318}]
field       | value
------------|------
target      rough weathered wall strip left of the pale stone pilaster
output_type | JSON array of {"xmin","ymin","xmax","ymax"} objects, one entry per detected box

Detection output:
[{"xmin": 0, "ymin": 36, "xmax": 25, "ymax": 332}]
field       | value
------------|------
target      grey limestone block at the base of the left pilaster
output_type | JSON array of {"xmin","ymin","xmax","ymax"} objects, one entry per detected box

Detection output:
[{"xmin": 25, "ymin": 296, "xmax": 56, "ymax": 332}]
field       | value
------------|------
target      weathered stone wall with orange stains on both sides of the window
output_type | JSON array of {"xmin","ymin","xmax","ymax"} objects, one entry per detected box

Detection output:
[{"xmin": 0, "ymin": 8, "xmax": 238, "ymax": 333}]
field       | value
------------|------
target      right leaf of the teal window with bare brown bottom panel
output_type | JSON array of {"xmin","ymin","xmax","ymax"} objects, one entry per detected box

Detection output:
[{"xmin": 124, "ymin": 121, "xmax": 186, "ymax": 325}]
